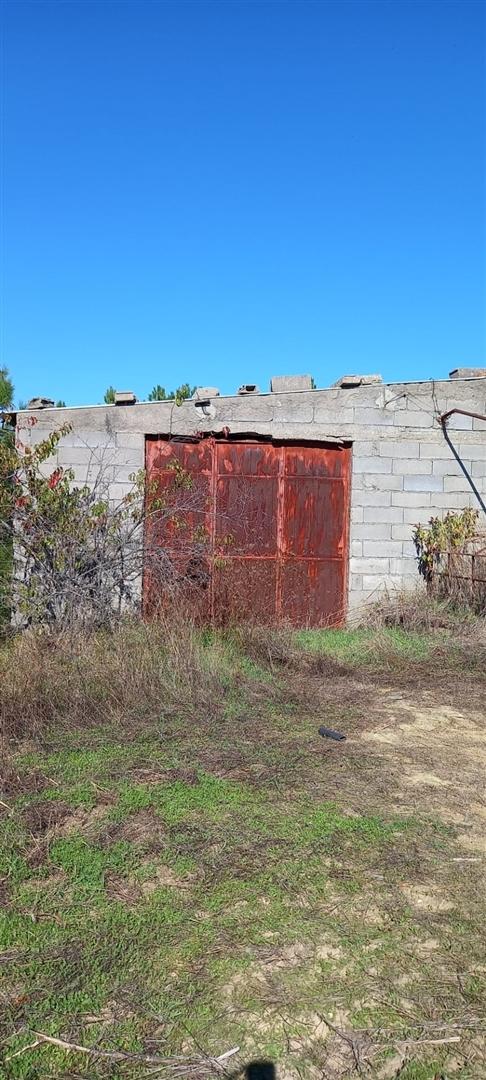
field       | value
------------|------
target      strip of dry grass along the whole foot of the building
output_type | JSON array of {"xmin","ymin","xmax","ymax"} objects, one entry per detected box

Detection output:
[{"xmin": 0, "ymin": 609, "xmax": 486, "ymax": 746}]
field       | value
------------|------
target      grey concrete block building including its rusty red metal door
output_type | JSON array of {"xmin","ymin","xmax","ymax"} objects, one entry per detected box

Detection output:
[{"xmin": 17, "ymin": 368, "xmax": 486, "ymax": 625}]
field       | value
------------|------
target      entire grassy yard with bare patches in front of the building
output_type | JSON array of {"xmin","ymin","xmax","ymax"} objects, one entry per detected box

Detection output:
[{"xmin": 0, "ymin": 626, "xmax": 486, "ymax": 1080}]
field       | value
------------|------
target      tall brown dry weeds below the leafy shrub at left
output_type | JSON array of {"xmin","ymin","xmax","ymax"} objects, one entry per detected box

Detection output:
[{"xmin": 0, "ymin": 619, "xmax": 236, "ymax": 740}]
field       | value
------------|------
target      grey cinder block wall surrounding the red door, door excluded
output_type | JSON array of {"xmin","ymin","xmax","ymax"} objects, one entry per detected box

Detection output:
[{"xmin": 17, "ymin": 377, "xmax": 486, "ymax": 610}]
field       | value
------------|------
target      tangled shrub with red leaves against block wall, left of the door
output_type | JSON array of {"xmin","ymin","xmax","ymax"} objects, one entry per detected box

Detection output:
[{"xmin": 0, "ymin": 417, "xmax": 140, "ymax": 625}]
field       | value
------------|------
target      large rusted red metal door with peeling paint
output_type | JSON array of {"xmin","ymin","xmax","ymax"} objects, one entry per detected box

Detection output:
[{"xmin": 145, "ymin": 437, "xmax": 351, "ymax": 626}]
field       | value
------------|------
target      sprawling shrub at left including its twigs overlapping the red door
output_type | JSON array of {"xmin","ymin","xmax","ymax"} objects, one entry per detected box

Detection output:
[{"xmin": 0, "ymin": 416, "xmax": 216, "ymax": 629}]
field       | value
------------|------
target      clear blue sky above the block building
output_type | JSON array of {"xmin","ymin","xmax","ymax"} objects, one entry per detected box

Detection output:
[{"xmin": 0, "ymin": 0, "xmax": 486, "ymax": 404}]
